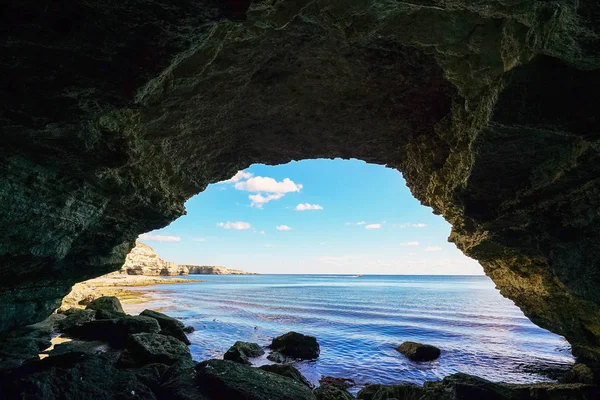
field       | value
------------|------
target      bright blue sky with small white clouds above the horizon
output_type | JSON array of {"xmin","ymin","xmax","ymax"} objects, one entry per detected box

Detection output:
[{"xmin": 139, "ymin": 159, "xmax": 483, "ymax": 275}]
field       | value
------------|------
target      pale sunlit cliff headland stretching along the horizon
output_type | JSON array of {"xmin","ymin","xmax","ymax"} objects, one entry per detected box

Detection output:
[{"xmin": 119, "ymin": 242, "xmax": 252, "ymax": 276}]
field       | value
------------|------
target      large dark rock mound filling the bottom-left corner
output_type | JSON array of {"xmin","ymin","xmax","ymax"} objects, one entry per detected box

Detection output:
[{"xmin": 0, "ymin": 353, "xmax": 156, "ymax": 400}]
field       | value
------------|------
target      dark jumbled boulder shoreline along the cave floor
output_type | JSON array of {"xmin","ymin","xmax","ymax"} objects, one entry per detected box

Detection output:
[{"xmin": 0, "ymin": 296, "xmax": 600, "ymax": 400}]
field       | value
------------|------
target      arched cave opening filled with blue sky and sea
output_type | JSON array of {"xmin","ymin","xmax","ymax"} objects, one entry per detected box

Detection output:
[{"xmin": 97, "ymin": 159, "xmax": 573, "ymax": 393}]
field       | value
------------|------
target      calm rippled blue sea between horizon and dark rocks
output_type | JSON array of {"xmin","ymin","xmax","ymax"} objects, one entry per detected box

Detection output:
[{"xmin": 120, "ymin": 275, "xmax": 573, "ymax": 387}]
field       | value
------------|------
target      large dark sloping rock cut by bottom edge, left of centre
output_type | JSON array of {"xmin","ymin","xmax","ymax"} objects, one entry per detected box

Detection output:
[{"xmin": 196, "ymin": 360, "xmax": 315, "ymax": 400}]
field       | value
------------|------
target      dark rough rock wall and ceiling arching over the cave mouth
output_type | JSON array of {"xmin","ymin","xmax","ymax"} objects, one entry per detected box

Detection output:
[{"xmin": 0, "ymin": 0, "xmax": 600, "ymax": 357}]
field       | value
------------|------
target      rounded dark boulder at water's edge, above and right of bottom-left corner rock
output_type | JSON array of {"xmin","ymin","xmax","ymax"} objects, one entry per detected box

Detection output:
[{"xmin": 126, "ymin": 333, "xmax": 192, "ymax": 365}]
